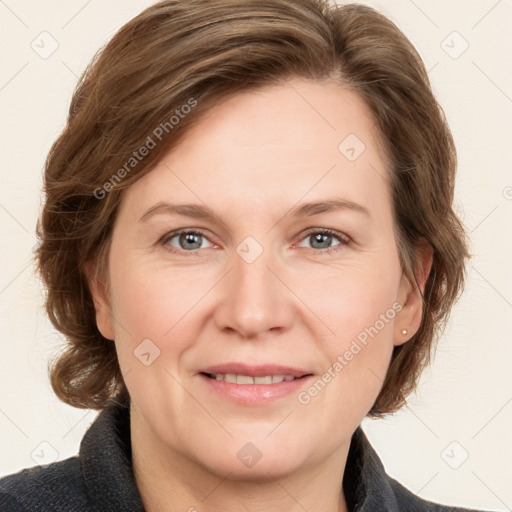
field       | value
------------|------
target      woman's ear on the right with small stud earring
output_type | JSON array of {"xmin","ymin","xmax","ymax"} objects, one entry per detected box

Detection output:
[{"xmin": 394, "ymin": 239, "xmax": 434, "ymax": 345}]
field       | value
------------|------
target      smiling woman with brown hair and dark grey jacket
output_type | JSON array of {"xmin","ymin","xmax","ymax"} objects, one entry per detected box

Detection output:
[{"xmin": 0, "ymin": 0, "xmax": 496, "ymax": 512}]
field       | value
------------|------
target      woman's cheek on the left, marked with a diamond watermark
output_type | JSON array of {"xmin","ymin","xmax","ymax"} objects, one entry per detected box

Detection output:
[{"xmin": 111, "ymin": 258, "xmax": 207, "ymax": 410}]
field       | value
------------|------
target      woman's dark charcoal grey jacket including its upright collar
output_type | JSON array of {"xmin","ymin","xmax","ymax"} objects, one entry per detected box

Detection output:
[{"xmin": 0, "ymin": 405, "xmax": 496, "ymax": 512}]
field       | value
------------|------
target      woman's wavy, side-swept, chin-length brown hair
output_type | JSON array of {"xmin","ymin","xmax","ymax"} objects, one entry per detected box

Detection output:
[{"xmin": 36, "ymin": 0, "xmax": 468, "ymax": 417}]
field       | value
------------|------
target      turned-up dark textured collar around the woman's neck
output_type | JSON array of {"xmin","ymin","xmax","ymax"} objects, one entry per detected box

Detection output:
[{"xmin": 79, "ymin": 404, "xmax": 399, "ymax": 512}]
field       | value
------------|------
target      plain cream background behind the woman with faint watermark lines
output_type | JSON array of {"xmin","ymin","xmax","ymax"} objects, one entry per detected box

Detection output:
[{"xmin": 0, "ymin": 0, "xmax": 512, "ymax": 511}]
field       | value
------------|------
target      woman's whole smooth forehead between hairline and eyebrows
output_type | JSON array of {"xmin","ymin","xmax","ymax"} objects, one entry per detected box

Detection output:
[{"xmin": 119, "ymin": 79, "xmax": 387, "ymax": 217}]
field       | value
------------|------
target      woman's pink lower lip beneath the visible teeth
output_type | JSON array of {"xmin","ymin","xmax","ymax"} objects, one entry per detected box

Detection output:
[{"xmin": 199, "ymin": 374, "xmax": 313, "ymax": 405}]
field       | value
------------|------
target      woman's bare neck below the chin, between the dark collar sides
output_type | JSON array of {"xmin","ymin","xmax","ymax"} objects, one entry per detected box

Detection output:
[{"xmin": 130, "ymin": 410, "xmax": 350, "ymax": 512}]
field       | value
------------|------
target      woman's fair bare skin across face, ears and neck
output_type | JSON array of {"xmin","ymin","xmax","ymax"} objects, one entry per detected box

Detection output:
[{"xmin": 90, "ymin": 78, "xmax": 432, "ymax": 512}]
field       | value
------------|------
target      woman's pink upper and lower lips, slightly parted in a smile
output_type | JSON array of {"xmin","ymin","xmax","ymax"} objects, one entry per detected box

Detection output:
[{"xmin": 198, "ymin": 363, "xmax": 313, "ymax": 406}]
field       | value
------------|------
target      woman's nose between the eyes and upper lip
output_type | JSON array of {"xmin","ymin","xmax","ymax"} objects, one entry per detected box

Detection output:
[{"xmin": 215, "ymin": 242, "xmax": 294, "ymax": 340}]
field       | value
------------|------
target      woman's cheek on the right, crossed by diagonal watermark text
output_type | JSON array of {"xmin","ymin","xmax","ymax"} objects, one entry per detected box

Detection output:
[{"xmin": 303, "ymin": 259, "xmax": 401, "ymax": 400}]
